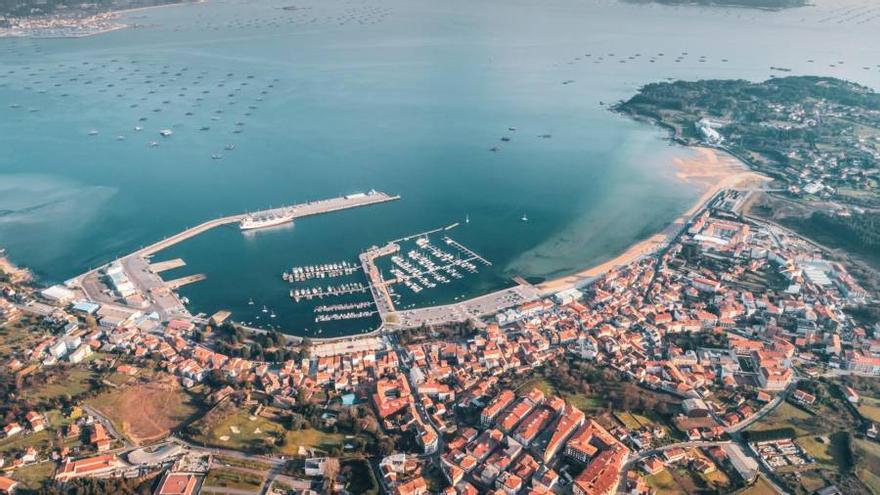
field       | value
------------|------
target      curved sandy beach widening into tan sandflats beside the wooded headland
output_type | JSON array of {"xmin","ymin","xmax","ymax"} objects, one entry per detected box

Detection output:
[{"xmin": 538, "ymin": 148, "xmax": 768, "ymax": 294}]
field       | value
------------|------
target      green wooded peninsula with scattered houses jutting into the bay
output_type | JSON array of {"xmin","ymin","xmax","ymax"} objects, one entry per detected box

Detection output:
[{"xmin": 615, "ymin": 76, "xmax": 880, "ymax": 272}]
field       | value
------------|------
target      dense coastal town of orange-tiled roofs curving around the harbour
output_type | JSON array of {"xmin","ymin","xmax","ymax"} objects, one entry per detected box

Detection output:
[{"xmin": 0, "ymin": 190, "xmax": 880, "ymax": 495}]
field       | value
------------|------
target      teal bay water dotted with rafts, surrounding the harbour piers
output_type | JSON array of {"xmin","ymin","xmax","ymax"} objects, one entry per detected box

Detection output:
[{"xmin": 0, "ymin": 0, "xmax": 880, "ymax": 336}]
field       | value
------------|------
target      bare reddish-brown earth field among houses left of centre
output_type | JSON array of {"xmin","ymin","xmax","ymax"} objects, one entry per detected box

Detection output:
[{"xmin": 88, "ymin": 379, "xmax": 200, "ymax": 443}]
